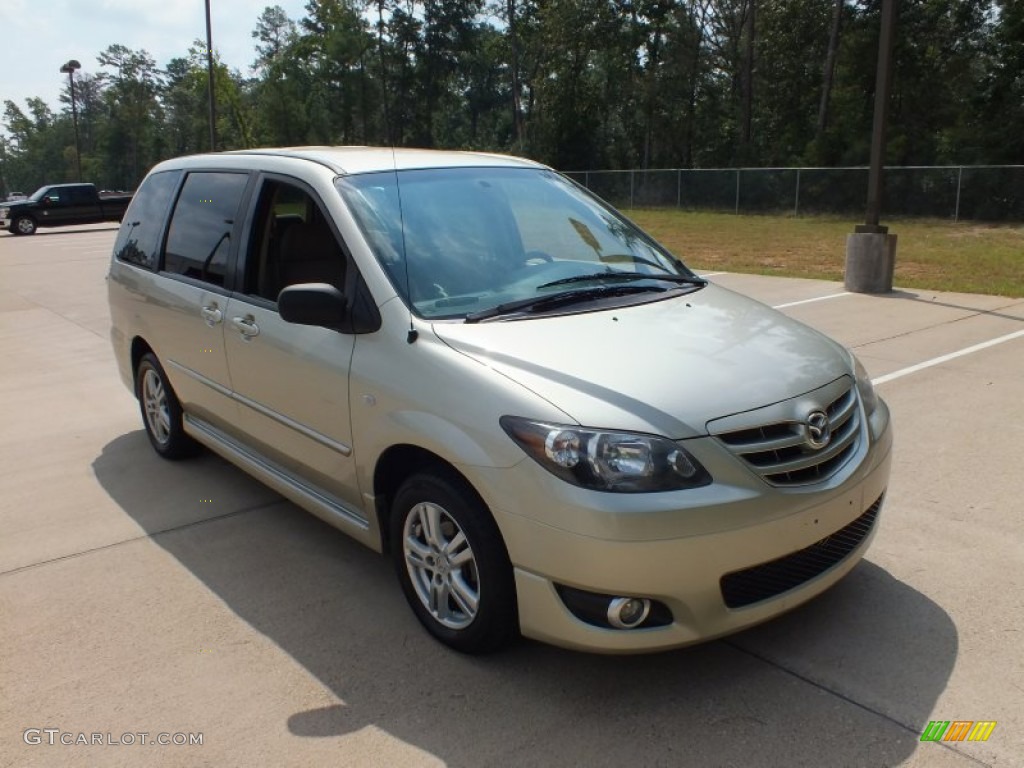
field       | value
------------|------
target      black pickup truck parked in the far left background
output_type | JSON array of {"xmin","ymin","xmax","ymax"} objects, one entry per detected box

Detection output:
[{"xmin": 0, "ymin": 184, "xmax": 132, "ymax": 234}]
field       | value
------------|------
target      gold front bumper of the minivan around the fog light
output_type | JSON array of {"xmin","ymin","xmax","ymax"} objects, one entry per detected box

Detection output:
[{"xmin": 471, "ymin": 403, "xmax": 892, "ymax": 652}]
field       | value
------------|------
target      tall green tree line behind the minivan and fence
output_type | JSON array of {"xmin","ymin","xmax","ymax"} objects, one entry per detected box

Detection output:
[{"xmin": 0, "ymin": 0, "xmax": 1024, "ymax": 191}]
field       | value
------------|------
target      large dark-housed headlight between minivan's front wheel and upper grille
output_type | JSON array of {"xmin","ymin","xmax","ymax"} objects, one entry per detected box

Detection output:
[{"xmin": 501, "ymin": 416, "xmax": 711, "ymax": 494}]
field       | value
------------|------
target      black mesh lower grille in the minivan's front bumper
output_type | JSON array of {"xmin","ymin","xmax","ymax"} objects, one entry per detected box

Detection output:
[{"xmin": 719, "ymin": 495, "xmax": 884, "ymax": 608}]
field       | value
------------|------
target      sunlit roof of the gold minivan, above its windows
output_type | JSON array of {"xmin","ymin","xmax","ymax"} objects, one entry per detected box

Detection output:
[{"xmin": 205, "ymin": 146, "xmax": 544, "ymax": 174}]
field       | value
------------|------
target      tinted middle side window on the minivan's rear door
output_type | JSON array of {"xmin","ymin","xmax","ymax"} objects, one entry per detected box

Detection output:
[{"xmin": 163, "ymin": 171, "xmax": 249, "ymax": 286}]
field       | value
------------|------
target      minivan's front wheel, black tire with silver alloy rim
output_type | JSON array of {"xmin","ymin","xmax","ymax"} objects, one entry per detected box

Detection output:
[{"xmin": 391, "ymin": 469, "xmax": 519, "ymax": 653}]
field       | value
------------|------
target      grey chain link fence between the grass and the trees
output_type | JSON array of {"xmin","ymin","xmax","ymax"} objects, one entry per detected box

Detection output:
[{"xmin": 565, "ymin": 165, "xmax": 1024, "ymax": 221}]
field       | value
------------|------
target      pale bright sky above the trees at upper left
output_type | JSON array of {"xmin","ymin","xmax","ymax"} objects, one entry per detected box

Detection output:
[{"xmin": 0, "ymin": 0, "xmax": 305, "ymax": 115}]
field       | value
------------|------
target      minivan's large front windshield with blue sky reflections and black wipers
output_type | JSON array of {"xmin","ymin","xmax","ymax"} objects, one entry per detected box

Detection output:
[{"xmin": 337, "ymin": 168, "xmax": 694, "ymax": 318}]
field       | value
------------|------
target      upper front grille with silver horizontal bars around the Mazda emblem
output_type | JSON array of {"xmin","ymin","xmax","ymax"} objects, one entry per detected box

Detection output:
[{"xmin": 718, "ymin": 384, "xmax": 860, "ymax": 485}]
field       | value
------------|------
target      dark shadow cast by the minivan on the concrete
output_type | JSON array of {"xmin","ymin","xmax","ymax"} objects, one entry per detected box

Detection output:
[{"xmin": 93, "ymin": 431, "xmax": 957, "ymax": 767}]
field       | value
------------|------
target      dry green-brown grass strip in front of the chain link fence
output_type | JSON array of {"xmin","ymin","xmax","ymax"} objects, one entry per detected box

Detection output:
[{"xmin": 626, "ymin": 208, "xmax": 1024, "ymax": 297}]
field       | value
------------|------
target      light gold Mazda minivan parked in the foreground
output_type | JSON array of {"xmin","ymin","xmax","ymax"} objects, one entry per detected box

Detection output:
[{"xmin": 108, "ymin": 147, "xmax": 892, "ymax": 652}]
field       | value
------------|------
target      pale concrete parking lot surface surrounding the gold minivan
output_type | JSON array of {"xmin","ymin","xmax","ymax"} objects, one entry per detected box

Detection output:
[{"xmin": 0, "ymin": 225, "xmax": 1024, "ymax": 768}]
